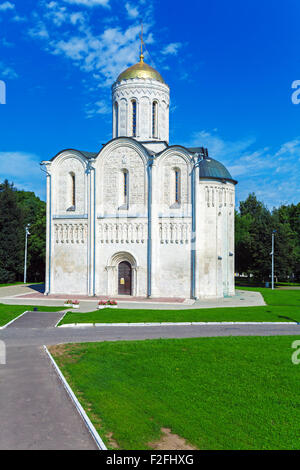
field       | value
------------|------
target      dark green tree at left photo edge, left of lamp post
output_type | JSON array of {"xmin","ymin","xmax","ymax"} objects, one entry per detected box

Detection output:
[{"xmin": 0, "ymin": 180, "xmax": 25, "ymax": 283}]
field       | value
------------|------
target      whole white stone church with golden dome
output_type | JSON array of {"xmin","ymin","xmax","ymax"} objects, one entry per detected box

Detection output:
[{"xmin": 42, "ymin": 49, "xmax": 236, "ymax": 299}]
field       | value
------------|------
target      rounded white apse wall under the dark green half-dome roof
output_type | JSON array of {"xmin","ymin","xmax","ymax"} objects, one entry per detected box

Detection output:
[{"xmin": 196, "ymin": 180, "xmax": 235, "ymax": 298}]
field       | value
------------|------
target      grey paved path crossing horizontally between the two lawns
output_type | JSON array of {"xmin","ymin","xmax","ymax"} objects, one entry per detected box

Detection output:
[{"xmin": 0, "ymin": 312, "xmax": 300, "ymax": 348}]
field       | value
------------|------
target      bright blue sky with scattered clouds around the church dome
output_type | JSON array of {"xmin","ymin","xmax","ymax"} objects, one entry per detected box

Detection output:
[{"xmin": 0, "ymin": 0, "xmax": 300, "ymax": 207}]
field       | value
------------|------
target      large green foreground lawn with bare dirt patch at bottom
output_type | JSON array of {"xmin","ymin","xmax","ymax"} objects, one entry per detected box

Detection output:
[{"xmin": 51, "ymin": 336, "xmax": 300, "ymax": 450}]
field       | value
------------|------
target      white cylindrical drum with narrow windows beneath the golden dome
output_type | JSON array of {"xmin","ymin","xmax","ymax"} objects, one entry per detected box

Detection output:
[{"xmin": 112, "ymin": 78, "xmax": 170, "ymax": 142}]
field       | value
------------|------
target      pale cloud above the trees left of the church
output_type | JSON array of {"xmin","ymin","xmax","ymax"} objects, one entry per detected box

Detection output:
[{"xmin": 0, "ymin": 151, "xmax": 46, "ymax": 199}]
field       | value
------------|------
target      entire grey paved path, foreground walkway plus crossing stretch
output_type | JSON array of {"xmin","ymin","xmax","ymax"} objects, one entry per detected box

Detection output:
[{"xmin": 0, "ymin": 312, "xmax": 300, "ymax": 450}]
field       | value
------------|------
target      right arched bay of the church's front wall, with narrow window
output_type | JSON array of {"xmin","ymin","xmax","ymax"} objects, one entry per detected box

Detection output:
[{"xmin": 152, "ymin": 147, "xmax": 192, "ymax": 298}]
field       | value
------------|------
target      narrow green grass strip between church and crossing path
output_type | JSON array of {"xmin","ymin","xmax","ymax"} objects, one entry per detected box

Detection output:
[{"xmin": 60, "ymin": 288, "xmax": 300, "ymax": 325}]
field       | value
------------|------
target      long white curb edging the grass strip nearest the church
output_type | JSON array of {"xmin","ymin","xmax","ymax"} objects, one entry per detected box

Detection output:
[{"xmin": 58, "ymin": 321, "xmax": 300, "ymax": 328}]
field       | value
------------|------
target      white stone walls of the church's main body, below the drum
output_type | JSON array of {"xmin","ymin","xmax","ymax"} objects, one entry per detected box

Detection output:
[{"xmin": 46, "ymin": 142, "xmax": 235, "ymax": 298}]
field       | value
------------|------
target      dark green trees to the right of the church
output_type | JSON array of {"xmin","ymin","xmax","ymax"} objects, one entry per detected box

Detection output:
[{"xmin": 235, "ymin": 193, "xmax": 300, "ymax": 282}]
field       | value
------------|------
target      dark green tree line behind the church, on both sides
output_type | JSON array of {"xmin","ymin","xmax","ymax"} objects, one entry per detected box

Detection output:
[{"xmin": 0, "ymin": 180, "xmax": 300, "ymax": 284}]
